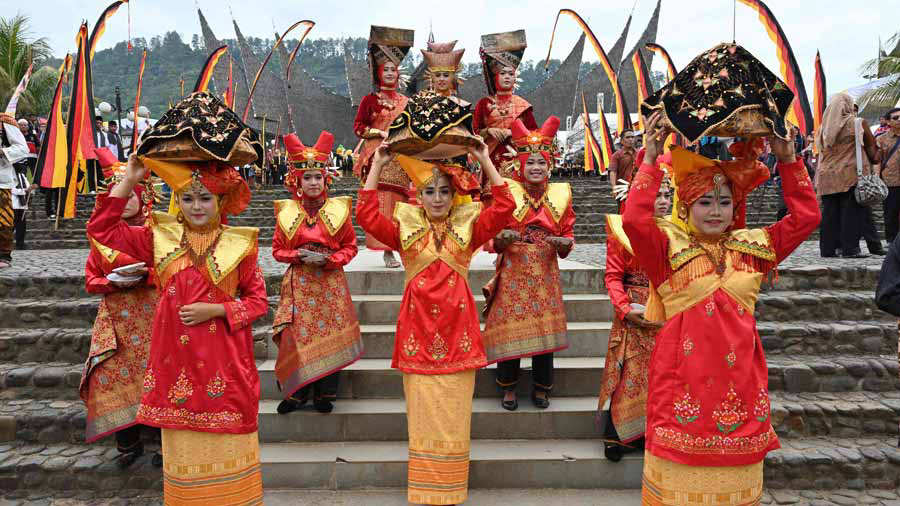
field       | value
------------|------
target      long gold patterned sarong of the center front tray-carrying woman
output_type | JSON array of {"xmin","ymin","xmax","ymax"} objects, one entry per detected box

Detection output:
[{"xmin": 403, "ymin": 370, "xmax": 475, "ymax": 504}]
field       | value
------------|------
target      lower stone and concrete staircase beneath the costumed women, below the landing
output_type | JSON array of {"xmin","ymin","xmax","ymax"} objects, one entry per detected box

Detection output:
[{"xmin": 0, "ymin": 243, "xmax": 900, "ymax": 500}]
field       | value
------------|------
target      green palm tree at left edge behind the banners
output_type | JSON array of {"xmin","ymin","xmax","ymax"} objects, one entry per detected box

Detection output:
[{"xmin": 0, "ymin": 14, "xmax": 56, "ymax": 115}]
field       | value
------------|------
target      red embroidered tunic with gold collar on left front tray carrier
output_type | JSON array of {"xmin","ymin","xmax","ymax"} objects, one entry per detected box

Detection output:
[{"xmin": 87, "ymin": 197, "xmax": 268, "ymax": 434}]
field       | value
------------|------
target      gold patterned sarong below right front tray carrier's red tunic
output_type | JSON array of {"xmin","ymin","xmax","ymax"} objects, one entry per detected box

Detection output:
[{"xmin": 641, "ymin": 452, "xmax": 763, "ymax": 506}]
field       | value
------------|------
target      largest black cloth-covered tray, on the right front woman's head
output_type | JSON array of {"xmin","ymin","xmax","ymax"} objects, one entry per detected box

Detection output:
[{"xmin": 641, "ymin": 43, "xmax": 794, "ymax": 143}]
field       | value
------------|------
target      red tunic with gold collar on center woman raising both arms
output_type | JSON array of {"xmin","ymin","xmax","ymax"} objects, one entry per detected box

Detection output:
[{"xmin": 356, "ymin": 185, "xmax": 514, "ymax": 374}]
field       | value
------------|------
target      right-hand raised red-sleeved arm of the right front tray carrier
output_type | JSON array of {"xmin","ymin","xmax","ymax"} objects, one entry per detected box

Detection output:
[{"xmin": 768, "ymin": 137, "xmax": 822, "ymax": 262}]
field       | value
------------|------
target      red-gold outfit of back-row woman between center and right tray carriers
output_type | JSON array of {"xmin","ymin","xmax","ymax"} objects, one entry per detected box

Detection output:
[{"xmin": 484, "ymin": 180, "xmax": 575, "ymax": 362}]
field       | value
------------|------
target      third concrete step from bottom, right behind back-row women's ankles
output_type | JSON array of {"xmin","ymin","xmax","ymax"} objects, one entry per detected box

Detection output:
[{"xmin": 257, "ymin": 357, "xmax": 605, "ymax": 400}]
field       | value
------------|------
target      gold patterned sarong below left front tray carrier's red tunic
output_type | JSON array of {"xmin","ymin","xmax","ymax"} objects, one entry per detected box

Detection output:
[{"xmin": 162, "ymin": 429, "xmax": 263, "ymax": 506}]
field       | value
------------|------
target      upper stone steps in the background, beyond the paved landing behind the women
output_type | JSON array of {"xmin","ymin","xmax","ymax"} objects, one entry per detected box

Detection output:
[{"xmin": 19, "ymin": 177, "xmax": 852, "ymax": 249}]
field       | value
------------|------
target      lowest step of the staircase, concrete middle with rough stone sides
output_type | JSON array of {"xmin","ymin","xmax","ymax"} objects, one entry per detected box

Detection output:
[{"xmin": 0, "ymin": 436, "xmax": 900, "ymax": 491}]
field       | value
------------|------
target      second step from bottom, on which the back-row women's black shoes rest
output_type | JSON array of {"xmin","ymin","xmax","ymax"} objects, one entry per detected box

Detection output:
[{"xmin": 10, "ymin": 387, "xmax": 900, "ymax": 445}]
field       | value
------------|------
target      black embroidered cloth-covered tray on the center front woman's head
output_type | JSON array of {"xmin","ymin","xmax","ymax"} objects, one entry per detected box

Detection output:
[{"xmin": 387, "ymin": 91, "xmax": 481, "ymax": 160}]
